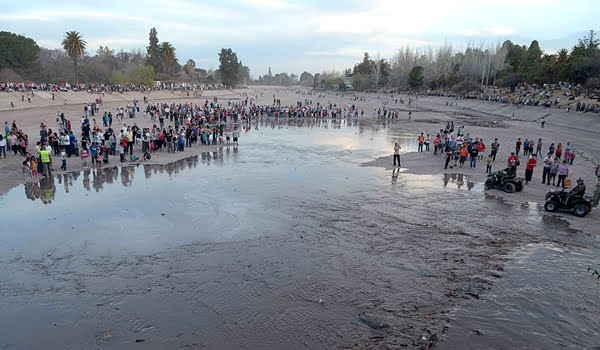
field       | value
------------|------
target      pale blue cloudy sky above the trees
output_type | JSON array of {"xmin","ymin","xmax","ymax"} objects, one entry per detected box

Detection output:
[{"xmin": 0, "ymin": 0, "xmax": 600, "ymax": 78}]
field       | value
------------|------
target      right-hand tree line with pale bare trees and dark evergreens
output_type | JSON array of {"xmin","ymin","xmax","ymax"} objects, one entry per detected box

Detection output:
[{"xmin": 344, "ymin": 31, "xmax": 600, "ymax": 92}]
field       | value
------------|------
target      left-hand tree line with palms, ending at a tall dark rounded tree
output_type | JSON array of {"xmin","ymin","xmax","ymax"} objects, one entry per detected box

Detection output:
[{"xmin": 0, "ymin": 28, "xmax": 250, "ymax": 87}]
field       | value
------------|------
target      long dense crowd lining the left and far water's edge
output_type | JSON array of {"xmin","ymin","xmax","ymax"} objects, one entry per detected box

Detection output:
[{"xmin": 0, "ymin": 89, "xmax": 368, "ymax": 181}]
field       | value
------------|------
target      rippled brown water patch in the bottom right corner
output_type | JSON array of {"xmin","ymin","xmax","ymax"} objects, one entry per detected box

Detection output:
[{"xmin": 440, "ymin": 244, "xmax": 600, "ymax": 349}]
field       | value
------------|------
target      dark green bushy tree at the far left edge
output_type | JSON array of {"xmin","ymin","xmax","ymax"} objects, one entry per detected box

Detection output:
[{"xmin": 0, "ymin": 32, "xmax": 40, "ymax": 70}]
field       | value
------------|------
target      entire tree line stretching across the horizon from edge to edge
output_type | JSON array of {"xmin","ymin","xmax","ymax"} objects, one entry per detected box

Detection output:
[{"xmin": 0, "ymin": 28, "xmax": 600, "ymax": 92}]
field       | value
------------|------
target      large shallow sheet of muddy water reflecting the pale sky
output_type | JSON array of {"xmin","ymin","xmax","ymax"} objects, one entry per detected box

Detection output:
[{"xmin": 0, "ymin": 121, "xmax": 595, "ymax": 349}]
